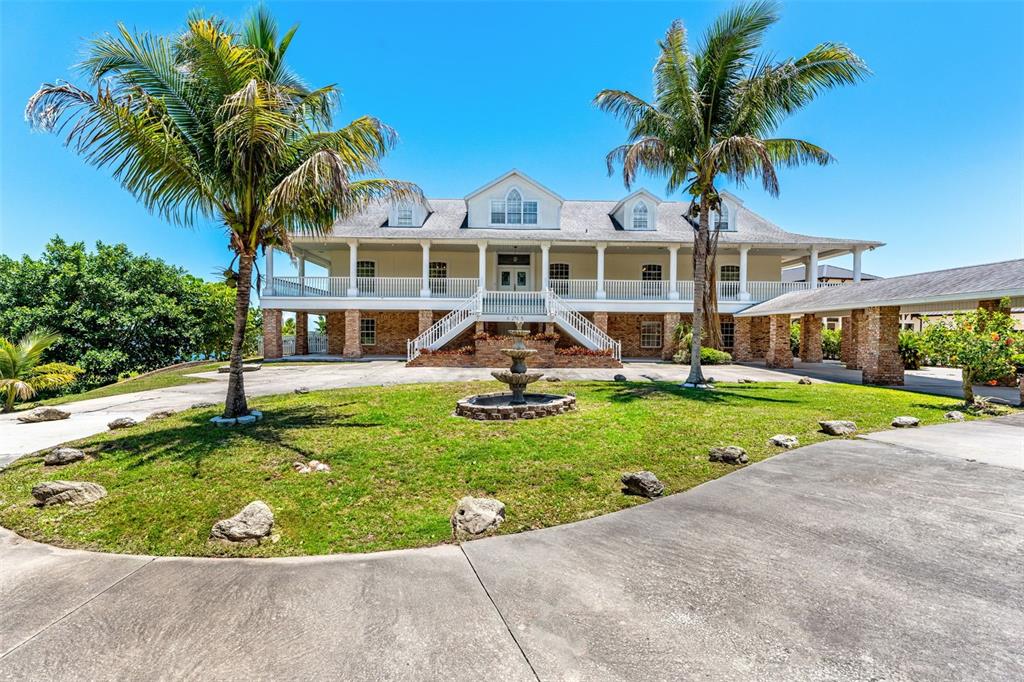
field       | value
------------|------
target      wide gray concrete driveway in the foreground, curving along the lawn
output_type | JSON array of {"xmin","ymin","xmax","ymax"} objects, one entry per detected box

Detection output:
[{"xmin": 0, "ymin": 415, "xmax": 1024, "ymax": 681}]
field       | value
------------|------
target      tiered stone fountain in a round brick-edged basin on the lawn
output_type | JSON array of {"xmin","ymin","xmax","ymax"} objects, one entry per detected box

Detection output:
[{"xmin": 455, "ymin": 321, "xmax": 575, "ymax": 420}]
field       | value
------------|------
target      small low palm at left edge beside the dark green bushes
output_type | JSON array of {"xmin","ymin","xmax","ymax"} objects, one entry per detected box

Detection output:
[{"xmin": 0, "ymin": 332, "xmax": 82, "ymax": 412}]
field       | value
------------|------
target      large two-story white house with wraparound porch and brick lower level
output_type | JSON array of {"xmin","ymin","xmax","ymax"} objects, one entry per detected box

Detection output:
[{"xmin": 261, "ymin": 170, "xmax": 882, "ymax": 364}]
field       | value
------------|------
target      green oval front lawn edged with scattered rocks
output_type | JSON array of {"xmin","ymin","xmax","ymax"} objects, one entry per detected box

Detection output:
[{"xmin": 0, "ymin": 382, "xmax": 987, "ymax": 556}]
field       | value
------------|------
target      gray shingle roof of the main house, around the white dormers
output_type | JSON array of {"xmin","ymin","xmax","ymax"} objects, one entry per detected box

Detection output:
[{"xmin": 315, "ymin": 199, "xmax": 882, "ymax": 250}]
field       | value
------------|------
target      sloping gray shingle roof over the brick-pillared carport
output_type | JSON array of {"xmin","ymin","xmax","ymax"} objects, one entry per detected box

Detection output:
[{"xmin": 737, "ymin": 259, "xmax": 1024, "ymax": 316}]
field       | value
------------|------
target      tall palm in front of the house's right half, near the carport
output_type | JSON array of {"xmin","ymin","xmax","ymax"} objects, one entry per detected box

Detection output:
[{"xmin": 594, "ymin": 2, "xmax": 869, "ymax": 386}]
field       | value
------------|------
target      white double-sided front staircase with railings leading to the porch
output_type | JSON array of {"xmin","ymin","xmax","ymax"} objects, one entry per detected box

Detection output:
[{"xmin": 406, "ymin": 291, "xmax": 622, "ymax": 361}]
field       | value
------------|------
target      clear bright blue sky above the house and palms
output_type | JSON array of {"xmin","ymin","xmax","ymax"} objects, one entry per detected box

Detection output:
[{"xmin": 0, "ymin": 0, "xmax": 1024, "ymax": 276}]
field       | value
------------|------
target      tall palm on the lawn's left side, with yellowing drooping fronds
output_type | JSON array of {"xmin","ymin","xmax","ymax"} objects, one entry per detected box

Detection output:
[{"xmin": 26, "ymin": 7, "xmax": 421, "ymax": 417}]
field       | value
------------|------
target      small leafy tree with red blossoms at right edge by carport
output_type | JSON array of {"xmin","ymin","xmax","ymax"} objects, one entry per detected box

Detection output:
[{"xmin": 921, "ymin": 308, "xmax": 1022, "ymax": 406}]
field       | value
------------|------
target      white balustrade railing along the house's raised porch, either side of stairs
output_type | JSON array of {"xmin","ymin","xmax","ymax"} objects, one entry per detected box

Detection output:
[{"xmin": 262, "ymin": 276, "xmax": 835, "ymax": 303}]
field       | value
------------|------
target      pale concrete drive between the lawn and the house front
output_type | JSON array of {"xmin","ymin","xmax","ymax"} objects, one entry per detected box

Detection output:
[{"xmin": 0, "ymin": 359, "xmax": 797, "ymax": 467}]
